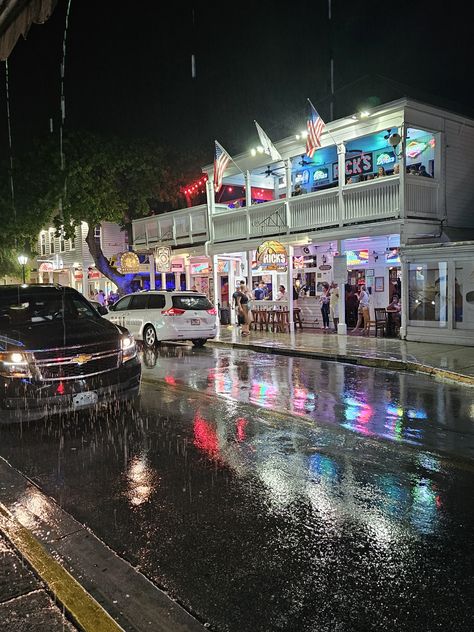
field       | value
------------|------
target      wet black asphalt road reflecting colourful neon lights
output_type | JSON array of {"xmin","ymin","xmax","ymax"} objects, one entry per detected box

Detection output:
[{"xmin": 0, "ymin": 347, "xmax": 474, "ymax": 632}]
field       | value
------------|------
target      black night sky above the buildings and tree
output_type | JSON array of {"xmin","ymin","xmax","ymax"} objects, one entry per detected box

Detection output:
[{"xmin": 0, "ymin": 0, "xmax": 474, "ymax": 167}]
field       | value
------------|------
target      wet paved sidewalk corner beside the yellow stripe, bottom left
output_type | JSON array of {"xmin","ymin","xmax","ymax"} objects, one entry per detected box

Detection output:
[{"xmin": 0, "ymin": 536, "xmax": 76, "ymax": 632}]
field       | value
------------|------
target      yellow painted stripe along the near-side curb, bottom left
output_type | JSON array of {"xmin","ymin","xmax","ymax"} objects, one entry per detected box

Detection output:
[{"xmin": 0, "ymin": 503, "xmax": 124, "ymax": 632}]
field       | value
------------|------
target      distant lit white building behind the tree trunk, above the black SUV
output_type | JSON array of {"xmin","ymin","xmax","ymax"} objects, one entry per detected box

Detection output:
[{"xmin": 32, "ymin": 222, "xmax": 128, "ymax": 297}]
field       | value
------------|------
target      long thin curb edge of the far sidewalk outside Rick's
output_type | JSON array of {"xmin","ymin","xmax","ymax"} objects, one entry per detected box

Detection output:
[{"xmin": 207, "ymin": 340, "xmax": 474, "ymax": 386}]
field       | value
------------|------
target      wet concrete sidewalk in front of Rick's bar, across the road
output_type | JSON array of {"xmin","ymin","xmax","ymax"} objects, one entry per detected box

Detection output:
[{"xmin": 208, "ymin": 326, "xmax": 474, "ymax": 386}]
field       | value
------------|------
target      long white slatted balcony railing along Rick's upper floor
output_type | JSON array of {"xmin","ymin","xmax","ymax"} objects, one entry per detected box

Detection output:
[{"xmin": 133, "ymin": 175, "xmax": 440, "ymax": 249}]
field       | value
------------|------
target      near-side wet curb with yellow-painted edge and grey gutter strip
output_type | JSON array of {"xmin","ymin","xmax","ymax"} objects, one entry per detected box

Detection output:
[{"xmin": 0, "ymin": 457, "xmax": 205, "ymax": 632}]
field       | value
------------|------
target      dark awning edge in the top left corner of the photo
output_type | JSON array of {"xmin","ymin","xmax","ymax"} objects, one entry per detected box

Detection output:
[{"xmin": 0, "ymin": 0, "xmax": 57, "ymax": 60}]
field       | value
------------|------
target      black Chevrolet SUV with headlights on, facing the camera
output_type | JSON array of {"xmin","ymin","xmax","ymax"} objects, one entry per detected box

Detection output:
[{"xmin": 0, "ymin": 285, "xmax": 141, "ymax": 423}]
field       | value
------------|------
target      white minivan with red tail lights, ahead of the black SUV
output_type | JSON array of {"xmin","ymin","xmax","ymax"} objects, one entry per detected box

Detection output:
[{"xmin": 104, "ymin": 291, "xmax": 217, "ymax": 348}]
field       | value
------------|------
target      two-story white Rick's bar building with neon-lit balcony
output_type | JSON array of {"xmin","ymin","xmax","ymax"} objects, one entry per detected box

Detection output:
[{"xmin": 133, "ymin": 99, "xmax": 474, "ymax": 344}]
